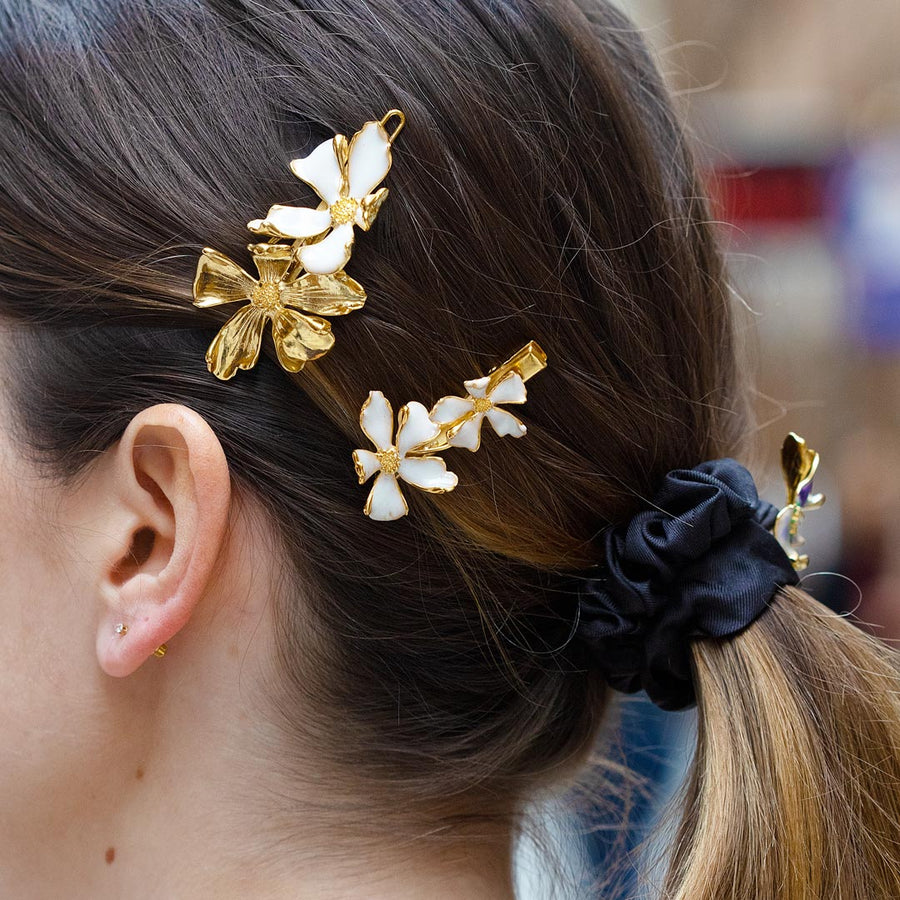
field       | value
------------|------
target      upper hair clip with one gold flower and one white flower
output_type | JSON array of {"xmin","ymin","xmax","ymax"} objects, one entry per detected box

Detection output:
[{"xmin": 194, "ymin": 109, "xmax": 406, "ymax": 380}]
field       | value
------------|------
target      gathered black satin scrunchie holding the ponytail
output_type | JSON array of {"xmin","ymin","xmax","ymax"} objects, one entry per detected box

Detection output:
[{"xmin": 577, "ymin": 458, "xmax": 799, "ymax": 709}]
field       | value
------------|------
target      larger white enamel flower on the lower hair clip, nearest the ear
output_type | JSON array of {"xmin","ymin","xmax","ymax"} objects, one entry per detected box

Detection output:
[{"xmin": 353, "ymin": 391, "xmax": 457, "ymax": 522}]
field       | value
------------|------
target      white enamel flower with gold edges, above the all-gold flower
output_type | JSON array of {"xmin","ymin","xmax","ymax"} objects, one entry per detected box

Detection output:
[{"xmin": 247, "ymin": 122, "xmax": 396, "ymax": 275}]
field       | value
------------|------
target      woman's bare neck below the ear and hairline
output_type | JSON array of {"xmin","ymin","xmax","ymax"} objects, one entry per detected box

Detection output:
[{"xmin": 0, "ymin": 608, "xmax": 514, "ymax": 900}]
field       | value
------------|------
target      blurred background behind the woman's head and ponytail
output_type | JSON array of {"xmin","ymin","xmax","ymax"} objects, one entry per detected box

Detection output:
[{"xmin": 540, "ymin": 0, "xmax": 900, "ymax": 900}]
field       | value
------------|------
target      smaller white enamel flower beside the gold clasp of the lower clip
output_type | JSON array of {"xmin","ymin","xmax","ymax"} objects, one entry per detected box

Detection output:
[{"xmin": 430, "ymin": 372, "xmax": 525, "ymax": 451}]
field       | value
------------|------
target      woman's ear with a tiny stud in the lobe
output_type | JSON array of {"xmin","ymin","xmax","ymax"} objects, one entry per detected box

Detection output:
[{"xmin": 91, "ymin": 403, "xmax": 231, "ymax": 676}]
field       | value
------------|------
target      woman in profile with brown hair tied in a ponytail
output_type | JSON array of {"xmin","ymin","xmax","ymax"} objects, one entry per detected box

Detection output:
[{"xmin": 0, "ymin": 0, "xmax": 900, "ymax": 900}]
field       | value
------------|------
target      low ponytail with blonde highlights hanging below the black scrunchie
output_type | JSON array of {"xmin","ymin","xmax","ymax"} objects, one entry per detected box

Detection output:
[{"xmin": 663, "ymin": 586, "xmax": 900, "ymax": 900}]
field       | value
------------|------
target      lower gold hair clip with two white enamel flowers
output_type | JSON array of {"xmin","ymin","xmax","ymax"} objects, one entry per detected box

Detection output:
[{"xmin": 353, "ymin": 341, "xmax": 547, "ymax": 522}]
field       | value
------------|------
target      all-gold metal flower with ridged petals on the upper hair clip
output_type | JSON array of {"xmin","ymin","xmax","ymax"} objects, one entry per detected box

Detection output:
[{"xmin": 194, "ymin": 244, "xmax": 366, "ymax": 381}]
